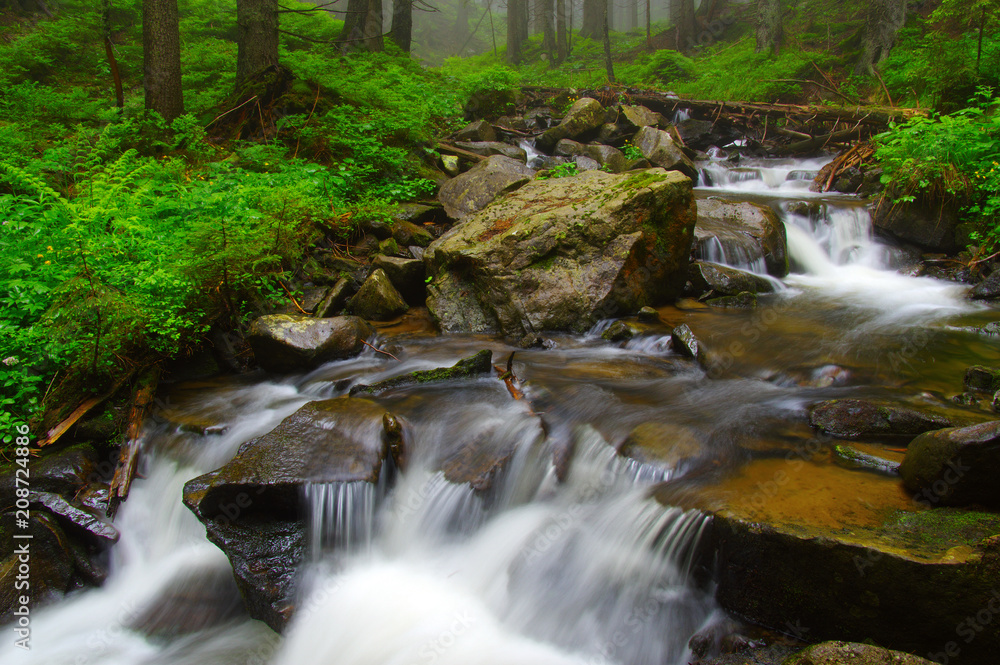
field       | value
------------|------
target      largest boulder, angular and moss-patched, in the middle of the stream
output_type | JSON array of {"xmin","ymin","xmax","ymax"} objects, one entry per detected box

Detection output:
[{"xmin": 424, "ymin": 169, "xmax": 696, "ymax": 337}]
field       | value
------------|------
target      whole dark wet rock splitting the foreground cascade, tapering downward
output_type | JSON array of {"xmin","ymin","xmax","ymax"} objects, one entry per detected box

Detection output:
[{"xmin": 184, "ymin": 397, "xmax": 403, "ymax": 631}]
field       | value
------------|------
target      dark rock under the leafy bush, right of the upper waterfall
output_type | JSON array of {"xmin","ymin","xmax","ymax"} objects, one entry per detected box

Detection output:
[{"xmin": 872, "ymin": 195, "xmax": 959, "ymax": 254}]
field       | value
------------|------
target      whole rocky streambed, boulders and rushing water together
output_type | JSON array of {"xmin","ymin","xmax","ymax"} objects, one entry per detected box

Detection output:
[{"xmin": 2, "ymin": 94, "xmax": 1000, "ymax": 664}]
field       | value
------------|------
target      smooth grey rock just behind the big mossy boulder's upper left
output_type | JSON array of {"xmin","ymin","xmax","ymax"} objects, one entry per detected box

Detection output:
[{"xmin": 438, "ymin": 155, "xmax": 535, "ymax": 219}]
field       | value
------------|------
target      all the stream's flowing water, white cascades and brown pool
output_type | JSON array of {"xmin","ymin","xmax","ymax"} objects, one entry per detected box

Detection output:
[{"xmin": 7, "ymin": 151, "xmax": 998, "ymax": 665}]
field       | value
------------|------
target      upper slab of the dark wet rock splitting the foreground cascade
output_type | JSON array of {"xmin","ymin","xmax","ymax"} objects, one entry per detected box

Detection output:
[{"xmin": 184, "ymin": 397, "xmax": 389, "ymax": 522}]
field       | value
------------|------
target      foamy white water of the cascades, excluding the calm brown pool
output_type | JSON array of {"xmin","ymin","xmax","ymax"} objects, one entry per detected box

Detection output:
[{"xmin": 0, "ymin": 153, "xmax": 975, "ymax": 665}]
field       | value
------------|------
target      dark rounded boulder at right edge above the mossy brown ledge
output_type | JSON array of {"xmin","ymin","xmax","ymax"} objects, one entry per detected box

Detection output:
[{"xmin": 899, "ymin": 421, "xmax": 1000, "ymax": 508}]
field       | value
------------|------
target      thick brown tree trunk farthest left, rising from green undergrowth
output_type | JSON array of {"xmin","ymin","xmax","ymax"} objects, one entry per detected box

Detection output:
[{"xmin": 142, "ymin": 0, "xmax": 184, "ymax": 121}]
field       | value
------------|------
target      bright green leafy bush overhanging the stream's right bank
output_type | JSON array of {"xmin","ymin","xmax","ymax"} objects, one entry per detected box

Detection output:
[{"xmin": 876, "ymin": 89, "xmax": 1000, "ymax": 246}]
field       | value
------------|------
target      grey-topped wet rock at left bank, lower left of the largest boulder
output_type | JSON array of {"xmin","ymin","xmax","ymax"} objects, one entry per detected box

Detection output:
[{"xmin": 247, "ymin": 314, "xmax": 376, "ymax": 372}]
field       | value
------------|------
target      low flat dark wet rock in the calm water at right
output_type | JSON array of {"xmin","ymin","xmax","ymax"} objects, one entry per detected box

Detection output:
[{"xmin": 809, "ymin": 399, "xmax": 954, "ymax": 439}]
